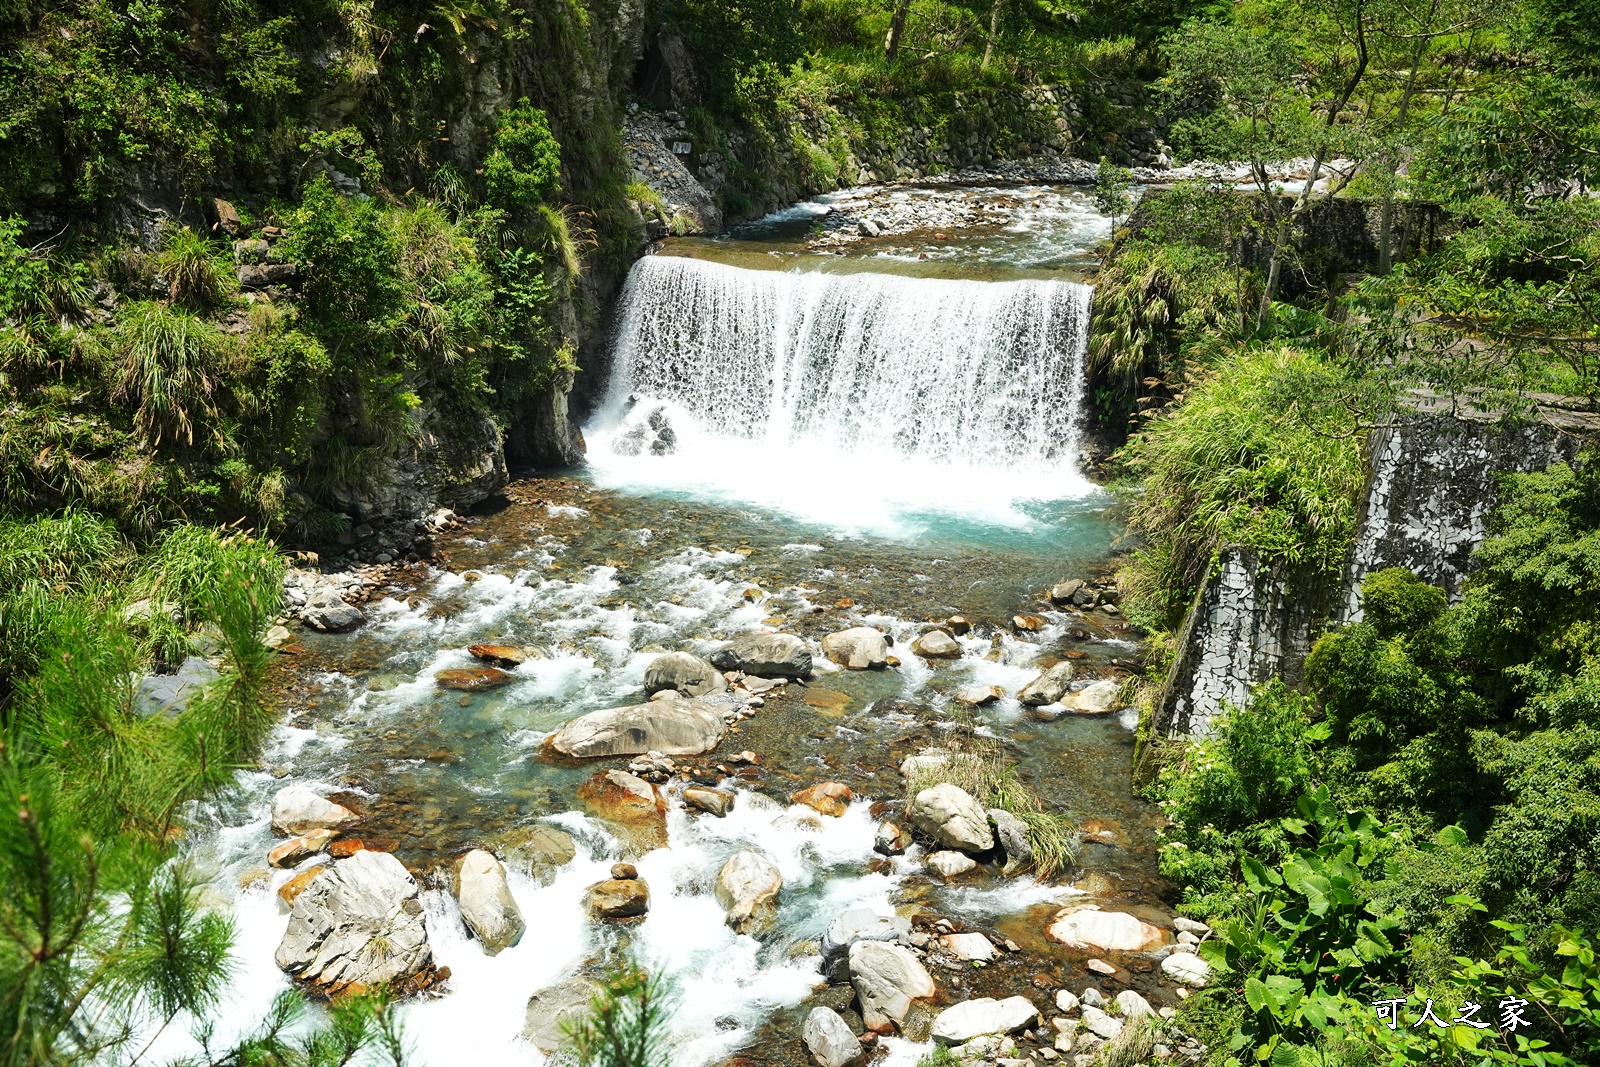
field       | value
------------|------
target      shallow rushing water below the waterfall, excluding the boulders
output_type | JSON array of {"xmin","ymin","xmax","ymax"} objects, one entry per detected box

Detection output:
[{"xmin": 152, "ymin": 183, "xmax": 1166, "ymax": 1067}]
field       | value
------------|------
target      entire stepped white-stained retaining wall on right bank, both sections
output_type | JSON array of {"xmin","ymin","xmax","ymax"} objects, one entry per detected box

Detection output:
[{"xmin": 1150, "ymin": 392, "xmax": 1600, "ymax": 739}]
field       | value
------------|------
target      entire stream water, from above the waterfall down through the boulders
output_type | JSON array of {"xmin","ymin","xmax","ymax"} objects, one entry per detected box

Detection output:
[{"xmin": 168, "ymin": 187, "xmax": 1173, "ymax": 1067}]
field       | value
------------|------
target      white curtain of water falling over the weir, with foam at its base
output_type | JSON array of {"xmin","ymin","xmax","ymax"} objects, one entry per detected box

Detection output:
[{"xmin": 586, "ymin": 256, "xmax": 1091, "ymax": 533}]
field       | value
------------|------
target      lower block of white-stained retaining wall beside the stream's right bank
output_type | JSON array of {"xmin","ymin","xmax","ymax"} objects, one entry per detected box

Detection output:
[{"xmin": 1152, "ymin": 545, "xmax": 1315, "ymax": 737}]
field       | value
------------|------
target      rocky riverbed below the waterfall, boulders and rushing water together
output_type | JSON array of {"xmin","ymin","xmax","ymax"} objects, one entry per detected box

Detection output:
[{"xmin": 156, "ymin": 478, "xmax": 1205, "ymax": 1065}]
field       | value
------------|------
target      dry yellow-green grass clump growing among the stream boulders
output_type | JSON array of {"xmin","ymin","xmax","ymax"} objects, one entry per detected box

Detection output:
[{"xmin": 906, "ymin": 721, "xmax": 1077, "ymax": 878}]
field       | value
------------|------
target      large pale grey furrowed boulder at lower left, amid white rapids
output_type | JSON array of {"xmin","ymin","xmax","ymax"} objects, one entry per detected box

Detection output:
[{"xmin": 275, "ymin": 851, "xmax": 434, "ymax": 995}]
